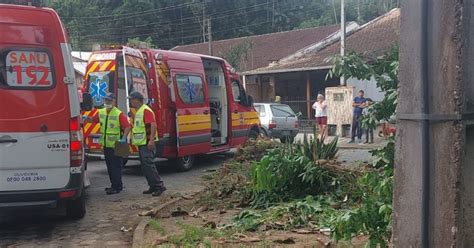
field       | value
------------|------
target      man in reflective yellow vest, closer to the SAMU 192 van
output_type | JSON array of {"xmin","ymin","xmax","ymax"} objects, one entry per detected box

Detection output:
[{"xmin": 86, "ymin": 93, "xmax": 130, "ymax": 195}]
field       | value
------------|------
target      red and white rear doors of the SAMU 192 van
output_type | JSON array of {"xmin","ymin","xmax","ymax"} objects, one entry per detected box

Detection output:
[{"xmin": 0, "ymin": 6, "xmax": 72, "ymax": 192}]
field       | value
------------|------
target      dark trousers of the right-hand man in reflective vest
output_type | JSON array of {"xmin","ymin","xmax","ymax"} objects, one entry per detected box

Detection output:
[{"xmin": 138, "ymin": 145, "xmax": 164, "ymax": 189}]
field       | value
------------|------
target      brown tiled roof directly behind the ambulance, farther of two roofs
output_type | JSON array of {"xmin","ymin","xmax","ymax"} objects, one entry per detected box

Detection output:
[{"xmin": 171, "ymin": 22, "xmax": 359, "ymax": 72}]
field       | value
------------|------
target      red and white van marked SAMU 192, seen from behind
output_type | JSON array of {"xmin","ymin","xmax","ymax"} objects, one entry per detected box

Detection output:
[{"xmin": 0, "ymin": 4, "xmax": 85, "ymax": 218}]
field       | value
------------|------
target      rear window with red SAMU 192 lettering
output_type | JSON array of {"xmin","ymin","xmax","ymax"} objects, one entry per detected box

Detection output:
[{"xmin": 0, "ymin": 50, "xmax": 55, "ymax": 89}]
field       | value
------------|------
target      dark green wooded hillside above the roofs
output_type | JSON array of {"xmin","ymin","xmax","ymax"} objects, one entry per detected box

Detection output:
[{"xmin": 44, "ymin": 0, "xmax": 397, "ymax": 50}]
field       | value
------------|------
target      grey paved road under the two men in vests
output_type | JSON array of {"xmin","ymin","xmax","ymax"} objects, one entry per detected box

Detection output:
[{"xmin": 0, "ymin": 156, "xmax": 225, "ymax": 247}]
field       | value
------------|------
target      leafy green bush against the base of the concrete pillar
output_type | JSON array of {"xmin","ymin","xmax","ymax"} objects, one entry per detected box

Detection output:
[{"xmin": 332, "ymin": 137, "xmax": 395, "ymax": 247}]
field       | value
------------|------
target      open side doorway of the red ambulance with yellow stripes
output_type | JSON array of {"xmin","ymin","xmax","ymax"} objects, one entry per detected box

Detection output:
[{"xmin": 203, "ymin": 59, "xmax": 229, "ymax": 146}]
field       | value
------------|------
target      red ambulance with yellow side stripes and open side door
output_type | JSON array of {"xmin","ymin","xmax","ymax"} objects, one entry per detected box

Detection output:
[{"xmin": 83, "ymin": 47, "xmax": 260, "ymax": 171}]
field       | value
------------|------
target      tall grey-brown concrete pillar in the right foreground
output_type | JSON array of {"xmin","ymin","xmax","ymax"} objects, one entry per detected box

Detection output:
[{"xmin": 393, "ymin": 0, "xmax": 468, "ymax": 247}]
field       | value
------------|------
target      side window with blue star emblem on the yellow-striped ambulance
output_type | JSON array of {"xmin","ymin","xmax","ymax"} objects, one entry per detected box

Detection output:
[{"xmin": 176, "ymin": 75, "xmax": 204, "ymax": 104}]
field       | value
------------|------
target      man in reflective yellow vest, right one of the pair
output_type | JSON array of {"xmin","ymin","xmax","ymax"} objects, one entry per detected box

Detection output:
[{"xmin": 128, "ymin": 91, "xmax": 166, "ymax": 196}]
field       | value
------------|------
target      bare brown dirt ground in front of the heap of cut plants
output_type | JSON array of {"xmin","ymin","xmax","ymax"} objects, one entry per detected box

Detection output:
[{"xmin": 141, "ymin": 196, "xmax": 366, "ymax": 247}]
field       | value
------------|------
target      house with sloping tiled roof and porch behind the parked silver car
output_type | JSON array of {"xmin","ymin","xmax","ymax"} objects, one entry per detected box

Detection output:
[{"xmin": 243, "ymin": 8, "xmax": 400, "ymax": 118}]
